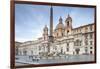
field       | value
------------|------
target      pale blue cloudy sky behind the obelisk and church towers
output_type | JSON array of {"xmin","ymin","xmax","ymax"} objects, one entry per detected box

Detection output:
[{"xmin": 15, "ymin": 4, "xmax": 94, "ymax": 42}]
